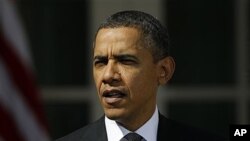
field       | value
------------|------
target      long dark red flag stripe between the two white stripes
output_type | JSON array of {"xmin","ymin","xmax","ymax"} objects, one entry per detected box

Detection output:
[{"xmin": 0, "ymin": 32, "xmax": 48, "ymax": 129}]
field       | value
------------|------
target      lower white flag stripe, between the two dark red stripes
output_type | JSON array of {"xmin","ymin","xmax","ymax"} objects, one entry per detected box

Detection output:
[{"xmin": 0, "ymin": 58, "xmax": 49, "ymax": 141}]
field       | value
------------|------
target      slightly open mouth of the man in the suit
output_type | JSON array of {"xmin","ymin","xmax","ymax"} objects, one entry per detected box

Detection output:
[{"xmin": 102, "ymin": 90, "xmax": 126, "ymax": 104}]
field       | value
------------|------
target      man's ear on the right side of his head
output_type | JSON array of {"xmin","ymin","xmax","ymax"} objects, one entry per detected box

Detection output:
[{"xmin": 157, "ymin": 56, "xmax": 175, "ymax": 85}]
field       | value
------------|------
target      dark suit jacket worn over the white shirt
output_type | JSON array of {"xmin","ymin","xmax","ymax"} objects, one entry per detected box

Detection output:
[{"xmin": 57, "ymin": 114, "xmax": 225, "ymax": 141}]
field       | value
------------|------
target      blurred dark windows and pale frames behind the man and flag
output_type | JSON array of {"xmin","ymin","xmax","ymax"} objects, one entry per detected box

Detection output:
[{"xmin": 1, "ymin": 0, "xmax": 250, "ymax": 139}]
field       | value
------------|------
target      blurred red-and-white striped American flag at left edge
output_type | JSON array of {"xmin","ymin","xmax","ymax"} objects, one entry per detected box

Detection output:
[{"xmin": 0, "ymin": 0, "xmax": 49, "ymax": 141}]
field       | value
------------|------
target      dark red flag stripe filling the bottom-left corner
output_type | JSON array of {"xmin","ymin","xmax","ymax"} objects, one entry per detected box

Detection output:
[{"xmin": 0, "ymin": 104, "xmax": 24, "ymax": 141}]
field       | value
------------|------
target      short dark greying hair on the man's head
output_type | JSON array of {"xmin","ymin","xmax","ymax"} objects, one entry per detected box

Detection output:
[{"xmin": 95, "ymin": 10, "xmax": 170, "ymax": 62}]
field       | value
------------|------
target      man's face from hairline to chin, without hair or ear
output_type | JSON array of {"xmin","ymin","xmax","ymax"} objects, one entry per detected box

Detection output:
[{"xmin": 93, "ymin": 27, "xmax": 159, "ymax": 122}]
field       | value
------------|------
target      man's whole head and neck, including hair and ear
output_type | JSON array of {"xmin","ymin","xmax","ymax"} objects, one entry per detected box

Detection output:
[{"xmin": 93, "ymin": 11, "xmax": 174, "ymax": 131}]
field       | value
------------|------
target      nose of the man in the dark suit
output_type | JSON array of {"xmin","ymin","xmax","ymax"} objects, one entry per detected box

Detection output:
[{"xmin": 103, "ymin": 60, "xmax": 121, "ymax": 86}]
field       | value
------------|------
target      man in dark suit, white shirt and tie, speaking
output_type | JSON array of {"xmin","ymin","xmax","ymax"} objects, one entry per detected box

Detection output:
[{"xmin": 59, "ymin": 11, "xmax": 227, "ymax": 141}]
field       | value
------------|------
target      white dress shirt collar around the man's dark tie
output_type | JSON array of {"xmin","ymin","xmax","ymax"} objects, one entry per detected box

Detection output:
[{"xmin": 105, "ymin": 106, "xmax": 159, "ymax": 141}]
